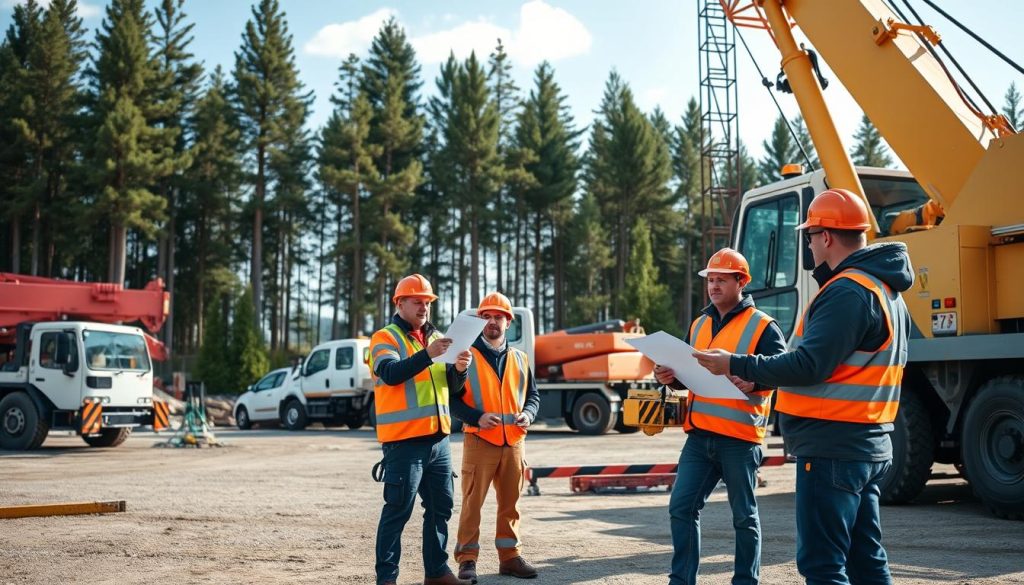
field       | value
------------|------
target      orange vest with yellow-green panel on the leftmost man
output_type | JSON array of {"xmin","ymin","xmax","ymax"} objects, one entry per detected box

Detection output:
[{"xmin": 370, "ymin": 323, "xmax": 452, "ymax": 443}]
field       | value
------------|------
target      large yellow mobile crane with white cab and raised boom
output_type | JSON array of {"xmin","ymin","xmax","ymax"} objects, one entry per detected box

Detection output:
[{"xmin": 720, "ymin": 0, "xmax": 1024, "ymax": 519}]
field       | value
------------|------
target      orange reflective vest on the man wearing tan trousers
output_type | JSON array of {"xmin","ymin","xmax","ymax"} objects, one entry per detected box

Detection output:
[{"xmin": 463, "ymin": 347, "xmax": 529, "ymax": 446}]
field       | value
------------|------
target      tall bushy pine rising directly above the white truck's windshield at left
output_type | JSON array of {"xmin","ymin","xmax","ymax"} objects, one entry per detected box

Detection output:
[{"xmin": 90, "ymin": 0, "xmax": 174, "ymax": 283}]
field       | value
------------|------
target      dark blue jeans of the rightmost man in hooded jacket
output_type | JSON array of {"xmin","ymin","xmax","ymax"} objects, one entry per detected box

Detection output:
[{"xmin": 797, "ymin": 457, "xmax": 892, "ymax": 585}]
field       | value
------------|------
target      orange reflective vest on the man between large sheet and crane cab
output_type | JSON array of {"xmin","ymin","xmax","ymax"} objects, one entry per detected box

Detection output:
[{"xmin": 683, "ymin": 306, "xmax": 773, "ymax": 443}]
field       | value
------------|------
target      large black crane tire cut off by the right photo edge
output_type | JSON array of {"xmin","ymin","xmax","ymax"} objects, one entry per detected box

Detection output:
[{"xmin": 963, "ymin": 376, "xmax": 1024, "ymax": 520}]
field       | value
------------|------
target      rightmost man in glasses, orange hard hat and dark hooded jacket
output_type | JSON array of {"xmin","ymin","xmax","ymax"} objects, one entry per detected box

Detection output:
[{"xmin": 694, "ymin": 189, "xmax": 913, "ymax": 584}]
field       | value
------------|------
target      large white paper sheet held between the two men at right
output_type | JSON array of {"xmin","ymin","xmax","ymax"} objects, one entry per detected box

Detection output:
[{"xmin": 626, "ymin": 331, "xmax": 748, "ymax": 400}]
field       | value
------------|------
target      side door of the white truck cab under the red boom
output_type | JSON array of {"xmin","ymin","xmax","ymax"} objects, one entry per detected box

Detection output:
[{"xmin": 29, "ymin": 331, "xmax": 82, "ymax": 410}]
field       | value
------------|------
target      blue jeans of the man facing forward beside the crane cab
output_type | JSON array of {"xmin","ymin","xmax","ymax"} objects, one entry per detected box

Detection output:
[{"xmin": 669, "ymin": 432, "xmax": 762, "ymax": 585}]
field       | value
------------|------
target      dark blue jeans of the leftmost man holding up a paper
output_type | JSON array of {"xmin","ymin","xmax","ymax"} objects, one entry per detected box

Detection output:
[{"xmin": 377, "ymin": 436, "xmax": 455, "ymax": 583}]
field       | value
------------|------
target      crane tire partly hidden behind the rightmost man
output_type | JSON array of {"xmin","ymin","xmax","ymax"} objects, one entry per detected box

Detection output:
[{"xmin": 881, "ymin": 386, "xmax": 935, "ymax": 504}]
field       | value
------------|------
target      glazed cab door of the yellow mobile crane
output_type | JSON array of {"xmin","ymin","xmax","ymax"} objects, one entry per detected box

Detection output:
[{"xmin": 736, "ymin": 187, "xmax": 814, "ymax": 339}]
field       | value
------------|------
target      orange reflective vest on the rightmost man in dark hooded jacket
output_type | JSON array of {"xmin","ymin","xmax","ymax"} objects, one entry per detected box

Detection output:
[{"xmin": 775, "ymin": 269, "xmax": 907, "ymax": 423}]
